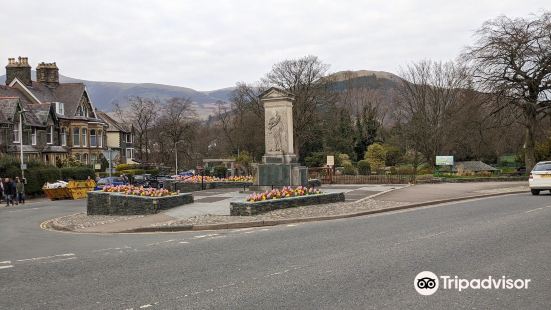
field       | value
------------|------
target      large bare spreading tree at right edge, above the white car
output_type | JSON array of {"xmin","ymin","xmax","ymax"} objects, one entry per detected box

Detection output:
[{"xmin": 463, "ymin": 12, "xmax": 551, "ymax": 170}]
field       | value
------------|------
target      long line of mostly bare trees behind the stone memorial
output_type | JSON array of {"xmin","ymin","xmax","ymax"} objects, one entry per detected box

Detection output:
[{"xmin": 117, "ymin": 12, "xmax": 551, "ymax": 169}]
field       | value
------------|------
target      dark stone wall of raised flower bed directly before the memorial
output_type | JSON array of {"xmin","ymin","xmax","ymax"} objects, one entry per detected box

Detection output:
[{"xmin": 230, "ymin": 193, "xmax": 344, "ymax": 216}]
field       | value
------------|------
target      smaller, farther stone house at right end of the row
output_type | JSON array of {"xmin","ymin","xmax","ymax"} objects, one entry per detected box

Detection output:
[{"xmin": 96, "ymin": 111, "xmax": 137, "ymax": 164}]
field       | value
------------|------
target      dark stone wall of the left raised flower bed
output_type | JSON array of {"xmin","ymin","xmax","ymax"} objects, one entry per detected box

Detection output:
[{"xmin": 86, "ymin": 192, "xmax": 193, "ymax": 215}]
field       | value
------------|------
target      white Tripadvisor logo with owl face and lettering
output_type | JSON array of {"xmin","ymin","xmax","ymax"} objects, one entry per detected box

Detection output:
[{"xmin": 413, "ymin": 271, "xmax": 532, "ymax": 296}]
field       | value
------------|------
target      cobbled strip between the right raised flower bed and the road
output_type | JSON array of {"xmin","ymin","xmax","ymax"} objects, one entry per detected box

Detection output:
[{"xmin": 157, "ymin": 199, "xmax": 406, "ymax": 227}]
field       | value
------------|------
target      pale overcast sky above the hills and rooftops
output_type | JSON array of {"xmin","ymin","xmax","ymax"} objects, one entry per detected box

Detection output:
[{"xmin": 0, "ymin": 0, "xmax": 551, "ymax": 90}]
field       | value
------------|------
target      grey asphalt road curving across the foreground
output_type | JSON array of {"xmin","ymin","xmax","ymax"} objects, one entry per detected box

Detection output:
[{"xmin": 0, "ymin": 194, "xmax": 551, "ymax": 309}]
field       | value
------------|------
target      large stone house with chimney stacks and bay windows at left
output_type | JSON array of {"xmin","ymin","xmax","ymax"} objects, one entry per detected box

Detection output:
[{"xmin": 0, "ymin": 57, "xmax": 108, "ymax": 164}]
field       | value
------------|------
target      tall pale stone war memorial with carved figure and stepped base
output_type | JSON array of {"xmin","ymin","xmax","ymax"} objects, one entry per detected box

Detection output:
[{"xmin": 255, "ymin": 87, "xmax": 308, "ymax": 188}]
